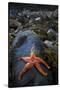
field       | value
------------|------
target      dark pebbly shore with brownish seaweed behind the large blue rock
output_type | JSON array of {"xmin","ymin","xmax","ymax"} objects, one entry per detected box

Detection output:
[{"xmin": 8, "ymin": 3, "xmax": 58, "ymax": 87}]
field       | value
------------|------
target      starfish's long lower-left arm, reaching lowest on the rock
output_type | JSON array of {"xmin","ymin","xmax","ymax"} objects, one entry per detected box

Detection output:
[{"xmin": 18, "ymin": 63, "xmax": 33, "ymax": 80}]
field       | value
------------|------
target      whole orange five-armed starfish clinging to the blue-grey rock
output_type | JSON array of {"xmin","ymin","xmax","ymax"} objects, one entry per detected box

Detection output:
[{"xmin": 19, "ymin": 46, "xmax": 50, "ymax": 80}]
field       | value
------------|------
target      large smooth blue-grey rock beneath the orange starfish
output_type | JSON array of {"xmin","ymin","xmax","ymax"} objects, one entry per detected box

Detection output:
[{"xmin": 9, "ymin": 30, "xmax": 53, "ymax": 87}]
